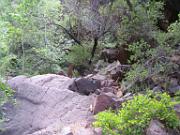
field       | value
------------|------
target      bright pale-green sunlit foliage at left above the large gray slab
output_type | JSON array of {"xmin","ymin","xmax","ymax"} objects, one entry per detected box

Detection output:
[{"xmin": 0, "ymin": 0, "xmax": 64, "ymax": 76}]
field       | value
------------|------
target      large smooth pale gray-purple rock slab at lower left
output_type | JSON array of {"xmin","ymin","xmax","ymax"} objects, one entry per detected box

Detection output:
[{"xmin": 0, "ymin": 74, "xmax": 94, "ymax": 135}]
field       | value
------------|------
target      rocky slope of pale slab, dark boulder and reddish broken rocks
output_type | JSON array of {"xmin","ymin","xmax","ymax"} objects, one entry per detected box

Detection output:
[{"xmin": 0, "ymin": 74, "xmax": 180, "ymax": 135}]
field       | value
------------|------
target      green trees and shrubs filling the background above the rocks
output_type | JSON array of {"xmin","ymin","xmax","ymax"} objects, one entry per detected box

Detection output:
[{"xmin": 0, "ymin": 0, "xmax": 180, "ymax": 83}]
